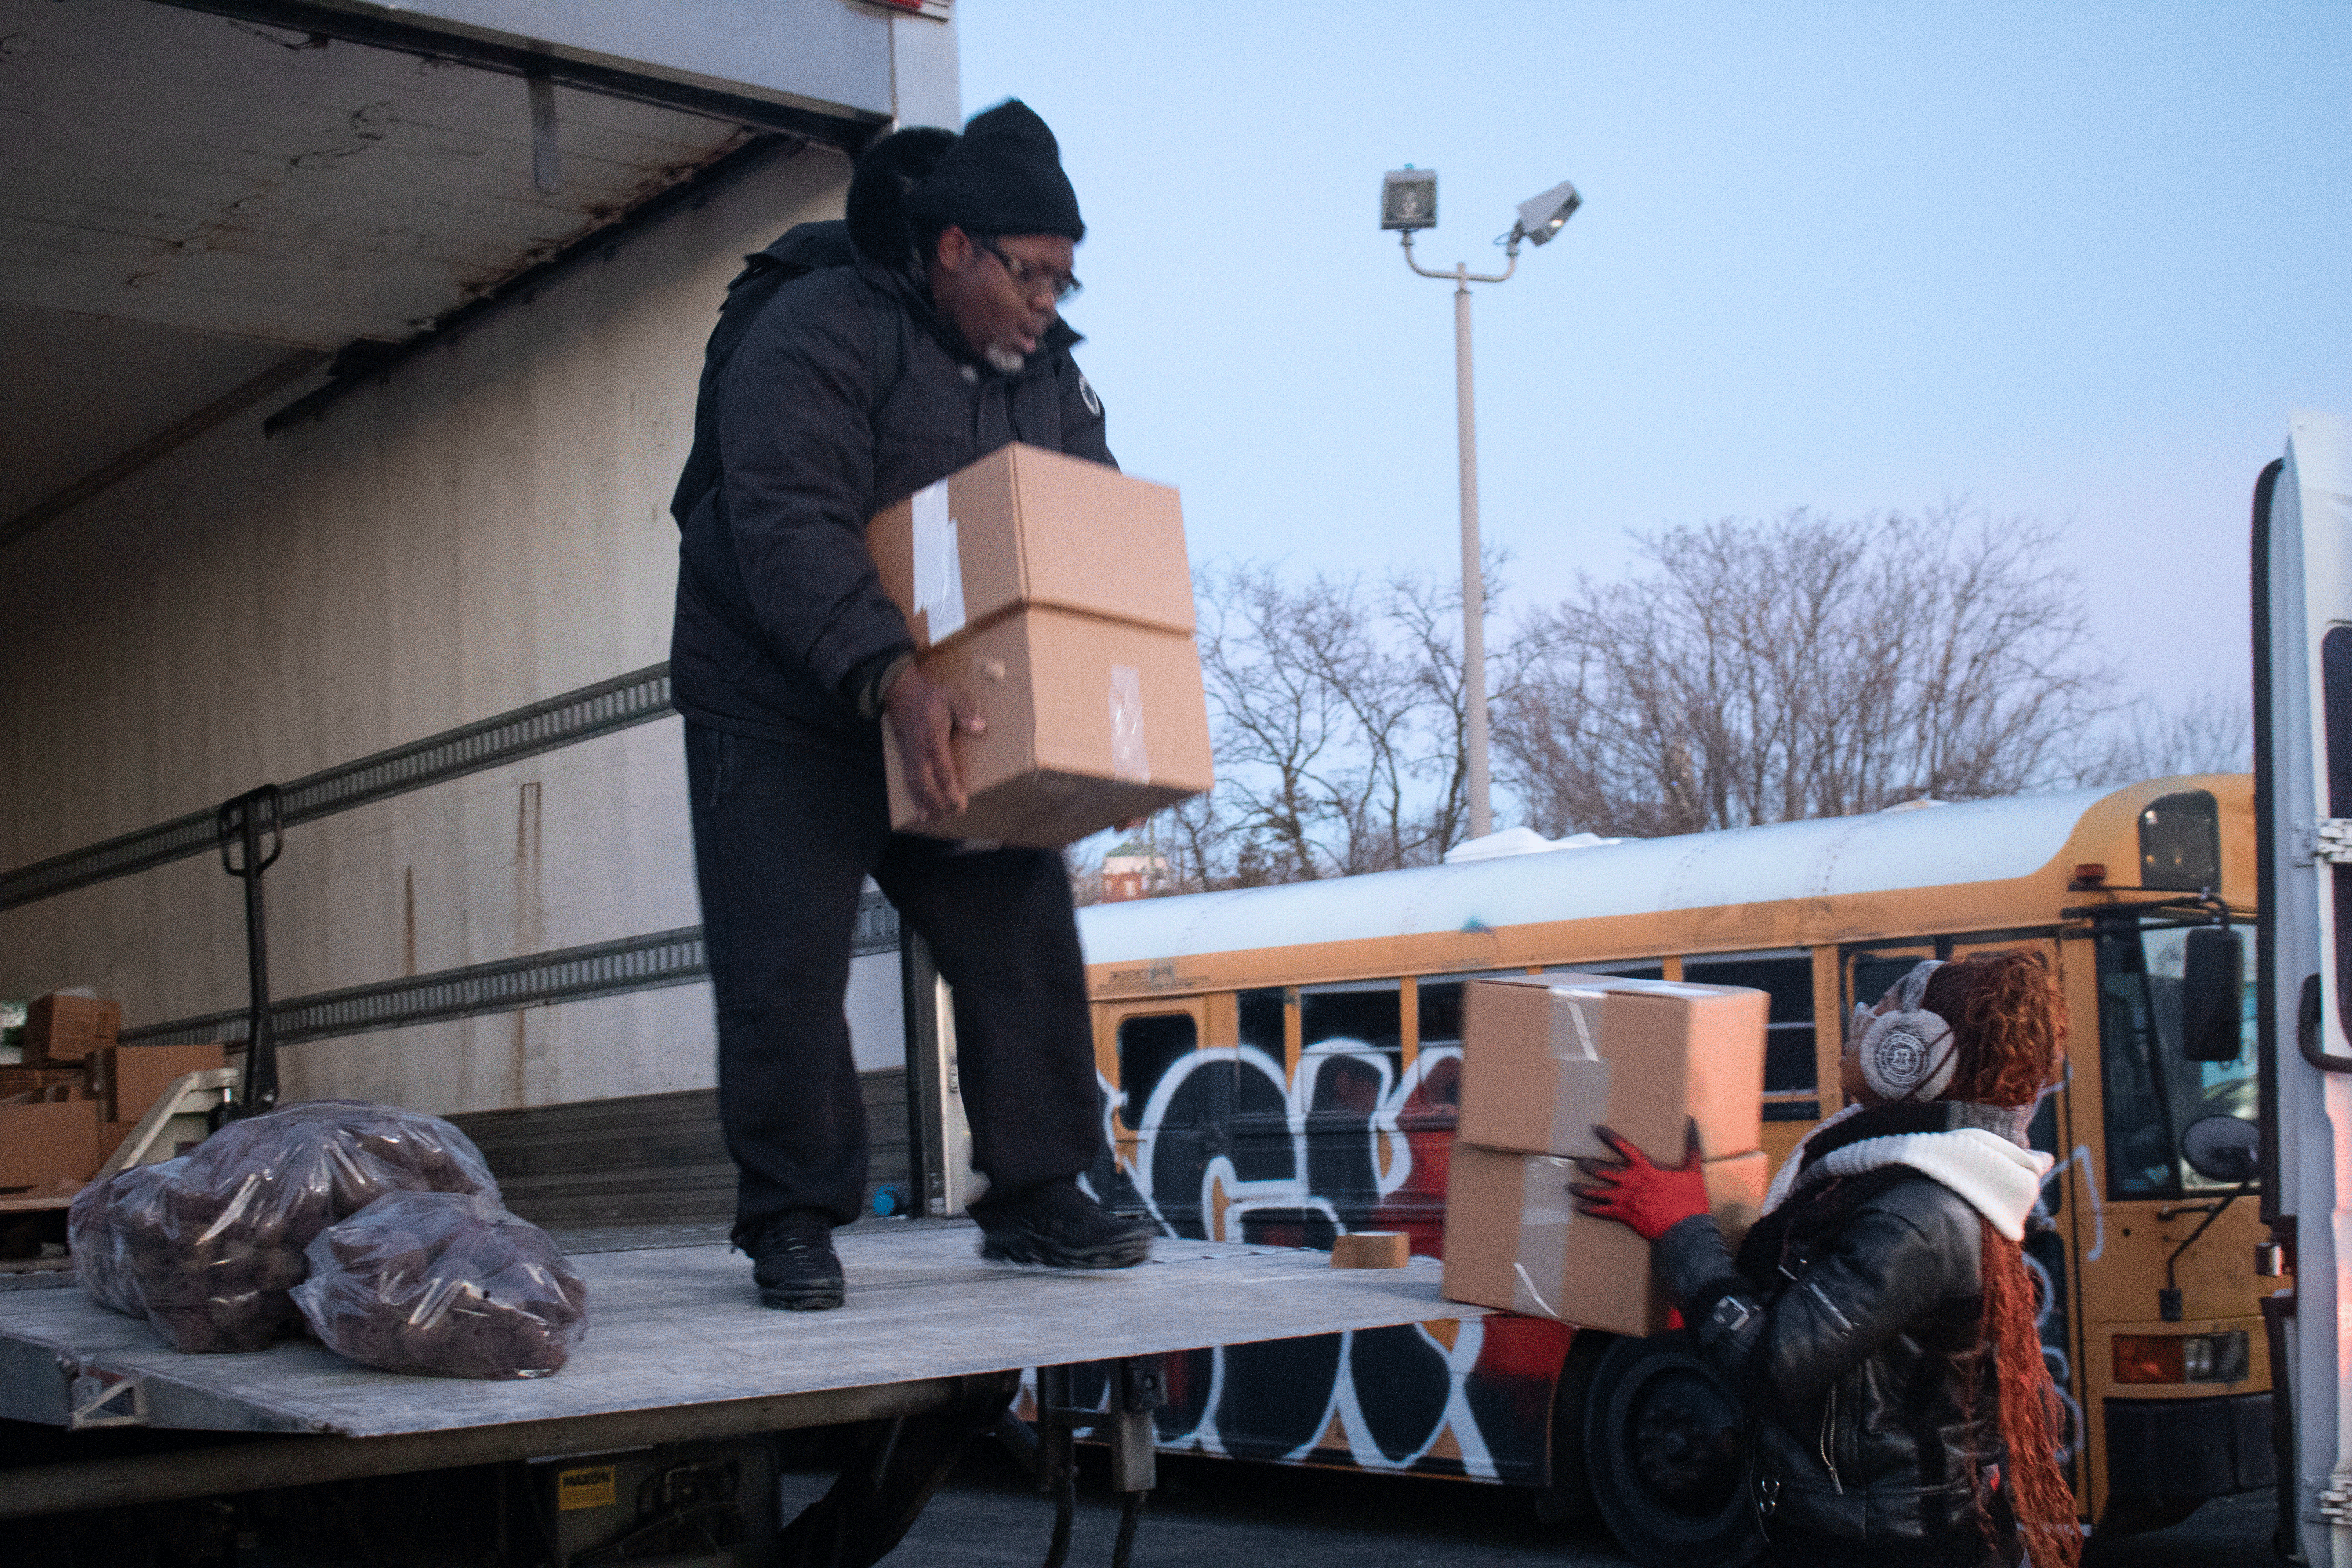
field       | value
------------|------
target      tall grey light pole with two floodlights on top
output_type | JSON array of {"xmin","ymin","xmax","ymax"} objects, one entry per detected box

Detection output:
[{"xmin": 1381, "ymin": 167, "xmax": 1583, "ymax": 839}]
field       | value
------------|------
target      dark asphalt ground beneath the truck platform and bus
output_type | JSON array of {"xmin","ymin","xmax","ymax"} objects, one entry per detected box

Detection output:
[{"xmin": 783, "ymin": 1441, "xmax": 2277, "ymax": 1568}]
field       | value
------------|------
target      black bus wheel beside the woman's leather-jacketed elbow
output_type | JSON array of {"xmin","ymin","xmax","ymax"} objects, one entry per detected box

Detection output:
[{"xmin": 1585, "ymin": 1333, "xmax": 1764, "ymax": 1568}]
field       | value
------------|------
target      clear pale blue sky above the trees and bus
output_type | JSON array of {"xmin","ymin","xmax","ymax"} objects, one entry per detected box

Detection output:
[{"xmin": 957, "ymin": 0, "xmax": 2352, "ymax": 696}]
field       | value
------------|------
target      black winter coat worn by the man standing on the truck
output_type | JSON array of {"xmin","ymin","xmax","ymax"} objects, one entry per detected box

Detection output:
[{"xmin": 670, "ymin": 263, "xmax": 1117, "ymax": 759}]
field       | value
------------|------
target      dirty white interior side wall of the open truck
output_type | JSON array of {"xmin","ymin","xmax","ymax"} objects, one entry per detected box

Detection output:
[{"xmin": 0, "ymin": 148, "xmax": 866, "ymax": 1112}]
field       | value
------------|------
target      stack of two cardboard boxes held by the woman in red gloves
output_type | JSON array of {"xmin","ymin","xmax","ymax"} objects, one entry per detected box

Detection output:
[{"xmin": 1444, "ymin": 976, "xmax": 1771, "ymax": 1335}]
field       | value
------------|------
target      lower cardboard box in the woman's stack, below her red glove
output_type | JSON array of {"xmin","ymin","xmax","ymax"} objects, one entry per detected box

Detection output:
[{"xmin": 1444, "ymin": 1143, "xmax": 1771, "ymax": 1335}]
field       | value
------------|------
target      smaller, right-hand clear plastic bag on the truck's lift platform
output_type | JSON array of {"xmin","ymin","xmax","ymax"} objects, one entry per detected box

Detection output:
[{"xmin": 294, "ymin": 1192, "xmax": 588, "ymax": 1377}]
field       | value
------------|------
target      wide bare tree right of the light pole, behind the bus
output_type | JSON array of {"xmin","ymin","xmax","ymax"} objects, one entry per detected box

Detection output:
[{"xmin": 1498, "ymin": 505, "xmax": 2114, "ymax": 837}]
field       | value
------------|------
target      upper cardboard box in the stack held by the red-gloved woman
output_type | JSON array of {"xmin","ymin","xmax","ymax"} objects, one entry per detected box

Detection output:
[{"xmin": 1458, "ymin": 976, "xmax": 1771, "ymax": 1166}]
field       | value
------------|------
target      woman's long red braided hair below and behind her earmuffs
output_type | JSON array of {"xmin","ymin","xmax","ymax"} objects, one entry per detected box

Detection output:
[{"xmin": 1924, "ymin": 947, "xmax": 2082, "ymax": 1568}]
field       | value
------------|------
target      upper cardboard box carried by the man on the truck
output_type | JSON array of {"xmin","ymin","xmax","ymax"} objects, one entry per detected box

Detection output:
[{"xmin": 866, "ymin": 444, "xmax": 1192, "ymax": 649}]
